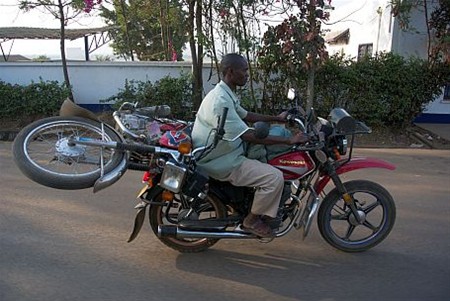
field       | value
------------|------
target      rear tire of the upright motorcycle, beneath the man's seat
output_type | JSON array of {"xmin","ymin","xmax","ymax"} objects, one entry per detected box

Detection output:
[{"xmin": 149, "ymin": 193, "xmax": 227, "ymax": 253}]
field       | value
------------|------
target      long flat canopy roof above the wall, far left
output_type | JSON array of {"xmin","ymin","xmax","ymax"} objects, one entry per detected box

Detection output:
[{"xmin": 0, "ymin": 27, "xmax": 111, "ymax": 40}]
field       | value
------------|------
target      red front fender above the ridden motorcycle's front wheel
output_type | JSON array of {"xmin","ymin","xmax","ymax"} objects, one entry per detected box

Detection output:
[{"xmin": 314, "ymin": 157, "xmax": 395, "ymax": 193}]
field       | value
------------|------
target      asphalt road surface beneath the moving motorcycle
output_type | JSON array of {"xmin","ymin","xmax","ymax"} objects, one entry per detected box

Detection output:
[{"xmin": 0, "ymin": 142, "xmax": 450, "ymax": 301}]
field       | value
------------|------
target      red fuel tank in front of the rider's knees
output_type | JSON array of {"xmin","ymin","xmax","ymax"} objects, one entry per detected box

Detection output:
[{"xmin": 268, "ymin": 152, "xmax": 315, "ymax": 180}]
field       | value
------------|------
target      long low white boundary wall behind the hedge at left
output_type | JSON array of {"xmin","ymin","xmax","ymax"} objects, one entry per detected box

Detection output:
[{"xmin": 0, "ymin": 62, "xmax": 217, "ymax": 104}]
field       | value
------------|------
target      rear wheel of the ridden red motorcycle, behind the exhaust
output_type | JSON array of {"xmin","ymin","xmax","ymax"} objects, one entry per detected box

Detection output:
[{"xmin": 149, "ymin": 194, "xmax": 227, "ymax": 253}]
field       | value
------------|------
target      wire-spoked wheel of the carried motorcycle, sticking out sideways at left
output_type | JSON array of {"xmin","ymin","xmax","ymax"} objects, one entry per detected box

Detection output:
[{"xmin": 12, "ymin": 116, "xmax": 125, "ymax": 190}]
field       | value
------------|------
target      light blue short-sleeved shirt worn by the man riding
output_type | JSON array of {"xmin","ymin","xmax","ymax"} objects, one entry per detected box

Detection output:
[{"xmin": 192, "ymin": 81, "xmax": 248, "ymax": 180}]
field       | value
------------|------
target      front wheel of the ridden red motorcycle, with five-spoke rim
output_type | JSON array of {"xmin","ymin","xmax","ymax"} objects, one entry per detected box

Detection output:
[{"xmin": 317, "ymin": 180, "xmax": 395, "ymax": 252}]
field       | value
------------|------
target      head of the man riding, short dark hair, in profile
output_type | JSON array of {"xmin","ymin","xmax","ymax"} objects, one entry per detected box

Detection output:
[{"xmin": 220, "ymin": 53, "xmax": 248, "ymax": 89}]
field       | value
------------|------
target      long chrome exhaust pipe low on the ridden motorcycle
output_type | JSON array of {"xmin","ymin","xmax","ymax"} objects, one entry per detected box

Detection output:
[{"xmin": 158, "ymin": 225, "xmax": 256, "ymax": 239}]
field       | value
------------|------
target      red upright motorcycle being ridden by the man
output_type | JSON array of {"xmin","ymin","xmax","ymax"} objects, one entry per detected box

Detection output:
[{"xmin": 129, "ymin": 108, "xmax": 396, "ymax": 252}]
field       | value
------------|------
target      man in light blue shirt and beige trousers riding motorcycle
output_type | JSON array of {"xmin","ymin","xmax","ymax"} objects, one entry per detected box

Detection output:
[{"xmin": 192, "ymin": 53, "xmax": 306, "ymax": 237}]
